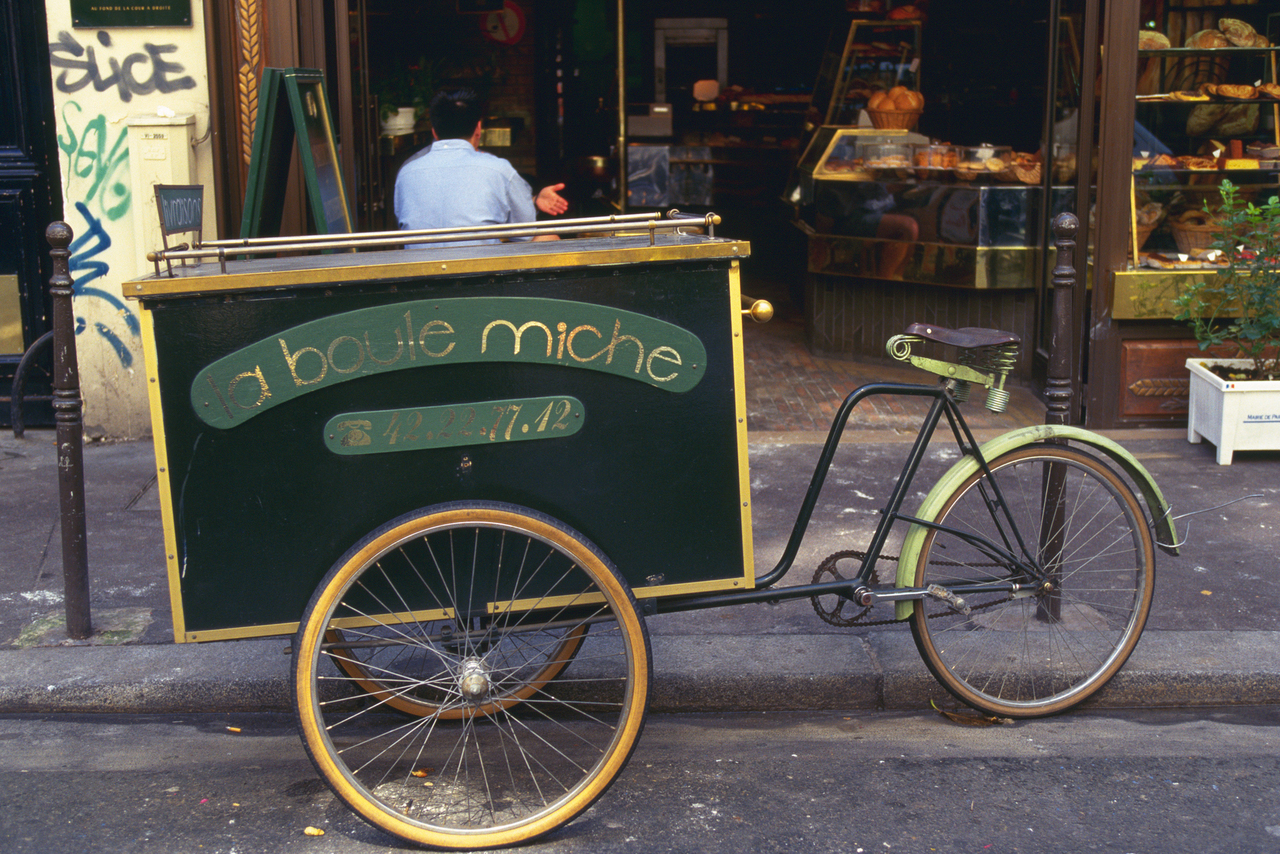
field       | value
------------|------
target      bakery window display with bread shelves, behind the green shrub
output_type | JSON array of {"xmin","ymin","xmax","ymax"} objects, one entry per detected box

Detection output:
[{"xmin": 1085, "ymin": 8, "xmax": 1280, "ymax": 428}]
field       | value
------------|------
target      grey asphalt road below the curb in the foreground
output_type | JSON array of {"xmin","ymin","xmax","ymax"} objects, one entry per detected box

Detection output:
[{"xmin": 0, "ymin": 707, "xmax": 1280, "ymax": 854}]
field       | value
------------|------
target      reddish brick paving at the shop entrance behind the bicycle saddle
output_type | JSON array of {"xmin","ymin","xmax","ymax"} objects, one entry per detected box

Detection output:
[{"xmin": 742, "ymin": 311, "xmax": 1044, "ymax": 435}]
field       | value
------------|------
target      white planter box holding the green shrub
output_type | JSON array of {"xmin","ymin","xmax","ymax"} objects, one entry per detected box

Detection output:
[{"xmin": 1187, "ymin": 359, "xmax": 1280, "ymax": 466}]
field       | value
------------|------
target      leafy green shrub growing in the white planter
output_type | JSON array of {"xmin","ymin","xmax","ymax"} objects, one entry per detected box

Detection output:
[{"xmin": 1174, "ymin": 181, "xmax": 1280, "ymax": 379}]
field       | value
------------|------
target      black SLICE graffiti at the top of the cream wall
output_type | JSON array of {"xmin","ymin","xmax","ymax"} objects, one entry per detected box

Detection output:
[{"xmin": 49, "ymin": 29, "xmax": 196, "ymax": 104}]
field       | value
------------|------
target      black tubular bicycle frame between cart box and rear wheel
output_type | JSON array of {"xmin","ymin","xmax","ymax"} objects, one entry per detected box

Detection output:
[{"xmin": 641, "ymin": 380, "xmax": 1041, "ymax": 613}]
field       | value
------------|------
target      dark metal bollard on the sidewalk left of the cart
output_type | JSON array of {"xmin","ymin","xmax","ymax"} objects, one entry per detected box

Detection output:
[{"xmin": 45, "ymin": 223, "xmax": 93, "ymax": 640}]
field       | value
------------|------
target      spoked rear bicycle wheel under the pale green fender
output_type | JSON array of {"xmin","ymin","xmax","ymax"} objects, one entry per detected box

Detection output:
[{"xmin": 911, "ymin": 444, "xmax": 1156, "ymax": 717}]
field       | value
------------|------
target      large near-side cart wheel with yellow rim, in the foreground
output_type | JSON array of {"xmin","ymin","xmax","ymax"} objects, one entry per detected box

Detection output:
[{"xmin": 293, "ymin": 504, "xmax": 650, "ymax": 849}]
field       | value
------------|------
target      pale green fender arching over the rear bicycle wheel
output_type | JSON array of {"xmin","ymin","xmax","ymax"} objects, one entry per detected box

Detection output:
[{"xmin": 896, "ymin": 424, "xmax": 1178, "ymax": 620}]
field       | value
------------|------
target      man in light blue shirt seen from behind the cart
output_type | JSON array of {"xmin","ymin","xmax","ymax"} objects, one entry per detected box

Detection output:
[{"xmin": 396, "ymin": 88, "xmax": 568, "ymax": 246}]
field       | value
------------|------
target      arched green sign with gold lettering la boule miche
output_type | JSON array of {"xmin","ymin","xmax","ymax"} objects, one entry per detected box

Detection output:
[{"xmin": 191, "ymin": 297, "xmax": 707, "ymax": 429}]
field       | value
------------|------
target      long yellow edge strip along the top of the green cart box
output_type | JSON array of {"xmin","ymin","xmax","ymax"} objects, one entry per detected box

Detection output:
[{"xmin": 123, "ymin": 239, "xmax": 751, "ymax": 300}]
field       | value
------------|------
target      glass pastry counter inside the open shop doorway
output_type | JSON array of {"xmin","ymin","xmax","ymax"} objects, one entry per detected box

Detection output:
[{"xmin": 787, "ymin": 125, "xmax": 1075, "ymax": 288}]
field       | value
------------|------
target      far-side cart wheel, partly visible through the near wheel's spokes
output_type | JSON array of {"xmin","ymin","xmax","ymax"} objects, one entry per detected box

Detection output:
[{"xmin": 325, "ymin": 620, "xmax": 589, "ymax": 721}]
